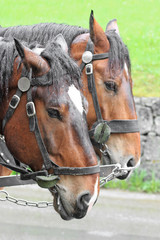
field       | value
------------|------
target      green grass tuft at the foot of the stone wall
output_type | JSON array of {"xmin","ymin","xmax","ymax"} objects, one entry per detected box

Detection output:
[{"xmin": 104, "ymin": 170, "xmax": 160, "ymax": 193}]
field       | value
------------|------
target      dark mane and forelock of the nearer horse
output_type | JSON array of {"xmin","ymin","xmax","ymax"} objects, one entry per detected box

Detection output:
[{"xmin": 0, "ymin": 38, "xmax": 82, "ymax": 102}]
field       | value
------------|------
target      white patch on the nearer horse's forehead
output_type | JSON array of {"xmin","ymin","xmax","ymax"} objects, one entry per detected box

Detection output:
[{"xmin": 68, "ymin": 84, "xmax": 83, "ymax": 114}]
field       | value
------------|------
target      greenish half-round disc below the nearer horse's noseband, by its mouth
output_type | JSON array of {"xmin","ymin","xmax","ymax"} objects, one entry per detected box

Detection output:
[{"xmin": 36, "ymin": 175, "xmax": 59, "ymax": 188}]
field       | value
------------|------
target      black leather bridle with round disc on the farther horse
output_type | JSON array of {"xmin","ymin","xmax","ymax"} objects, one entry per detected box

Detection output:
[{"xmin": 80, "ymin": 39, "xmax": 139, "ymax": 150}]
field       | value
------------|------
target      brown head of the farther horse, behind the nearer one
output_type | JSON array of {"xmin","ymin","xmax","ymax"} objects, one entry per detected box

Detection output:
[{"xmin": 71, "ymin": 12, "xmax": 140, "ymax": 179}]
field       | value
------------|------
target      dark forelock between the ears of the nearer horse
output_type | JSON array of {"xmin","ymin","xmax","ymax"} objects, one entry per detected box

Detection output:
[{"xmin": 32, "ymin": 41, "xmax": 82, "ymax": 90}]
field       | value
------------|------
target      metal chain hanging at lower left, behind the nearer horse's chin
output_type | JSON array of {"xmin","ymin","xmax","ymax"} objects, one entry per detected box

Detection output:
[{"xmin": 0, "ymin": 190, "xmax": 53, "ymax": 208}]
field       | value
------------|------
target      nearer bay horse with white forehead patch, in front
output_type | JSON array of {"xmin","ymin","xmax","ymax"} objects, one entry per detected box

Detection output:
[{"xmin": 0, "ymin": 36, "xmax": 99, "ymax": 220}]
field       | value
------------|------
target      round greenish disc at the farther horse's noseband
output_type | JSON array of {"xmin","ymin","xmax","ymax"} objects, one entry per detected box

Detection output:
[{"xmin": 93, "ymin": 122, "xmax": 111, "ymax": 144}]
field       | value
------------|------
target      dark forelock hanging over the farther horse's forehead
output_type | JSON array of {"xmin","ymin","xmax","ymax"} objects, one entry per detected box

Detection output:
[{"xmin": 106, "ymin": 30, "xmax": 131, "ymax": 77}]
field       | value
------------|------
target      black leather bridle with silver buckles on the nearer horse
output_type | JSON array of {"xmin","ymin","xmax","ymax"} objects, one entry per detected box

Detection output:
[{"xmin": 1, "ymin": 67, "xmax": 100, "ymax": 182}]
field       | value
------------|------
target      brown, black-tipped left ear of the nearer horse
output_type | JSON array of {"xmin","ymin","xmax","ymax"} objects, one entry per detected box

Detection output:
[{"xmin": 14, "ymin": 38, "xmax": 50, "ymax": 76}]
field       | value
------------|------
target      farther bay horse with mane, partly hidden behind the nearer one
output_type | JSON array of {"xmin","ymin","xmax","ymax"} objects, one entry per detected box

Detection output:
[{"xmin": 0, "ymin": 11, "xmax": 141, "ymax": 179}]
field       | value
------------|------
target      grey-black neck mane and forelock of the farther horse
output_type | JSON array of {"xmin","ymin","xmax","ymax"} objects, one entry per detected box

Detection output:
[{"xmin": 0, "ymin": 23, "xmax": 131, "ymax": 86}]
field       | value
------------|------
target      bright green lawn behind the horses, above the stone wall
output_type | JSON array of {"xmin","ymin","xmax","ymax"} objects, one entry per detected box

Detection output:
[{"xmin": 0, "ymin": 0, "xmax": 160, "ymax": 97}]
